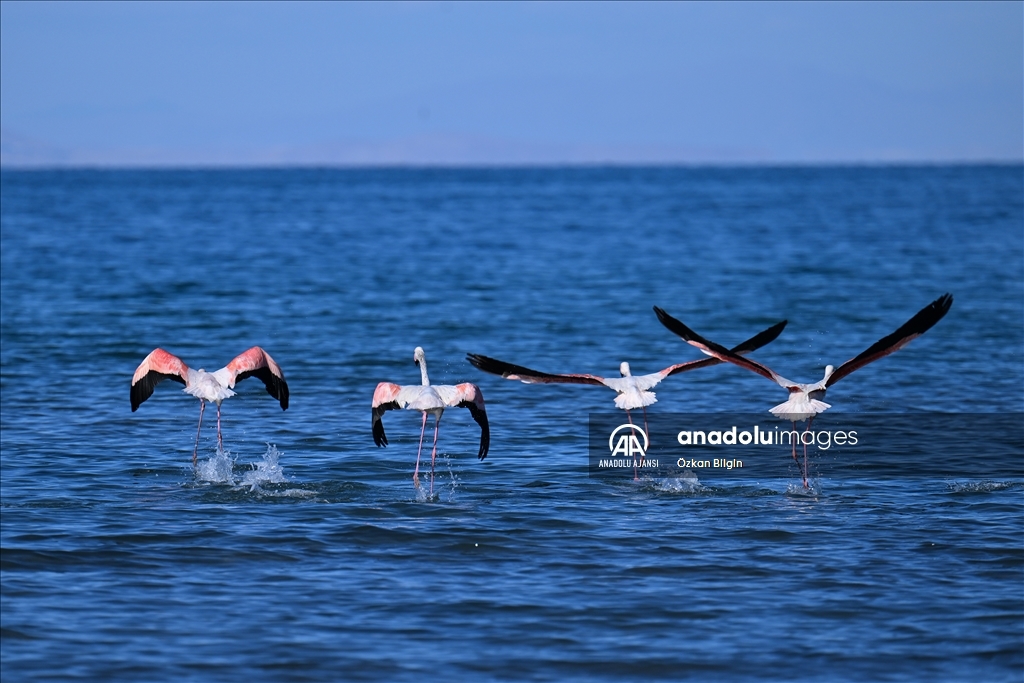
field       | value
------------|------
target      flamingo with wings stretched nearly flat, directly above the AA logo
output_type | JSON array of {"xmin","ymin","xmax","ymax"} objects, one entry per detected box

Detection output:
[{"xmin": 466, "ymin": 321, "xmax": 786, "ymax": 479}]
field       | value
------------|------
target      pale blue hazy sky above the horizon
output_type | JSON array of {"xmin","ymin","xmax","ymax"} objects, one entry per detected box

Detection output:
[{"xmin": 0, "ymin": 2, "xmax": 1024, "ymax": 166}]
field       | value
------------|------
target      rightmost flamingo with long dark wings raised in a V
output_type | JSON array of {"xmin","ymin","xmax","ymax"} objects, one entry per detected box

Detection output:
[{"xmin": 654, "ymin": 293, "xmax": 953, "ymax": 488}]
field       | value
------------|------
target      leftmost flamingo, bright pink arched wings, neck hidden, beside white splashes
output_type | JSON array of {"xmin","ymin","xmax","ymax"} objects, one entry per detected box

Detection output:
[{"xmin": 131, "ymin": 346, "xmax": 288, "ymax": 467}]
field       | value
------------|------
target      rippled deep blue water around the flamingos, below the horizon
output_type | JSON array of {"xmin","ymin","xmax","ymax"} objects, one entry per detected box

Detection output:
[{"xmin": 0, "ymin": 166, "xmax": 1024, "ymax": 682}]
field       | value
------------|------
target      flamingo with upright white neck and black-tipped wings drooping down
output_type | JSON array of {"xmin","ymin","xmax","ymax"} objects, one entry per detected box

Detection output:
[{"xmin": 372, "ymin": 346, "xmax": 490, "ymax": 496}]
